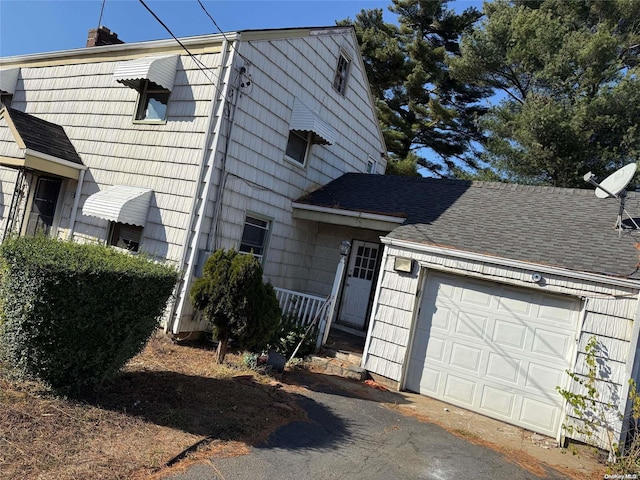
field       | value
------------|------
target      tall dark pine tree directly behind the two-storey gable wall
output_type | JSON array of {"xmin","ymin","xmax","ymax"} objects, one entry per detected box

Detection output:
[{"xmin": 340, "ymin": 0, "xmax": 490, "ymax": 176}]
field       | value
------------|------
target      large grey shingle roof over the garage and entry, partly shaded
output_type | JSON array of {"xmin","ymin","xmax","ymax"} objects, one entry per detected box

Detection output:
[{"xmin": 298, "ymin": 173, "xmax": 640, "ymax": 279}]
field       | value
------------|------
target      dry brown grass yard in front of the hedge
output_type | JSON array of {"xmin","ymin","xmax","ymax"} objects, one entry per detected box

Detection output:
[{"xmin": 0, "ymin": 335, "xmax": 304, "ymax": 480}]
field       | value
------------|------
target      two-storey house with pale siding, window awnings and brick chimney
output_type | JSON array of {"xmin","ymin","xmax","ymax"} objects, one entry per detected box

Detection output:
[{"xmin": 0, "ymin": 27, "xmax": 386, "ymax": 336}]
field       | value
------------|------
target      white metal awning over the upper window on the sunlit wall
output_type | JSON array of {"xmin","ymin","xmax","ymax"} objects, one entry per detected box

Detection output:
[{"xmin": 113, "ymin": 55, "xmax": 178, "ymax": 91}]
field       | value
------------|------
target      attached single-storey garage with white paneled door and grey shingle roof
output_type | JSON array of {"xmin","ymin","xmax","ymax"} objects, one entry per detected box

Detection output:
[{"xmin": 294, "ymin": 173, "xmax": 640, "ymax": 449}]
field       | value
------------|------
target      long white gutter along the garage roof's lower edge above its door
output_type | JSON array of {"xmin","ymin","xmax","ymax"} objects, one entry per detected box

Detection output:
[{"xmin": 380, "ymin": 237, "xmax": 640, "ymax": 290}]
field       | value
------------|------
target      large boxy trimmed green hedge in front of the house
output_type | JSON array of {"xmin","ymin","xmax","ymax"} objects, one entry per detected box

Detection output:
[{"xmin": 0, "ymin": 236, "xmax": 177, "ymax": 395}]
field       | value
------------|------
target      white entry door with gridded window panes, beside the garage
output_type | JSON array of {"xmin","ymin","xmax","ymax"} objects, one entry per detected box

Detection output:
[{"xmin": 339, "ymin": 240, "xmax": 380, "ymax": 330}]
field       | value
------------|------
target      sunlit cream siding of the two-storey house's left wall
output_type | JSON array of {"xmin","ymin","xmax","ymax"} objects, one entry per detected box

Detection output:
[{"xmin": 9, "ymin": 50, "xmax": 225, "ymax": 261}]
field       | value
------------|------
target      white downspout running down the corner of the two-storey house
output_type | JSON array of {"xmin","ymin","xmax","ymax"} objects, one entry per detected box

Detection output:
[{"xmin": 165, "ymin": 39, "xmax": 235, "ymax": 333}]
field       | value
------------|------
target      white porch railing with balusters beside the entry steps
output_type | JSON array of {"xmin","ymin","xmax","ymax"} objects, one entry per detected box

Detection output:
[{"xmin": 274, "ymin": 287, "xmax": 332, "ymax": 348}]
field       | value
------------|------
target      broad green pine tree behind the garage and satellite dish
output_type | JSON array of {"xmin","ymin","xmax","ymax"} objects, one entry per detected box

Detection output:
[{"xmin": 448, "ymin": 0, "xmax": 640, "ymax": 187}]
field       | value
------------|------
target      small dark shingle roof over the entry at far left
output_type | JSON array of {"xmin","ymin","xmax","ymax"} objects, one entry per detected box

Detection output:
[{"xmin": 7, "ymin": 108, "xmax": 82, "ymax": 165}]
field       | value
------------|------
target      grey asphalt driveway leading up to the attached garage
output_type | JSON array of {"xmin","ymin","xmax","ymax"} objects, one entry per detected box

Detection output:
[{"xmin": 168, "ymin": 375, "xmax": 568, "ymax": 480}]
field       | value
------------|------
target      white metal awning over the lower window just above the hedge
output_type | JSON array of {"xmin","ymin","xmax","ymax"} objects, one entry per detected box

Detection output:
[{"xmin": 82, "ymin": 185, "xmax": 153, "ymax": 227}]
